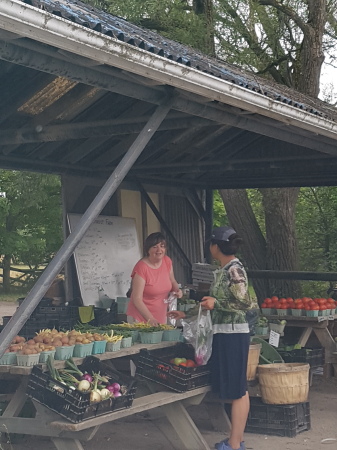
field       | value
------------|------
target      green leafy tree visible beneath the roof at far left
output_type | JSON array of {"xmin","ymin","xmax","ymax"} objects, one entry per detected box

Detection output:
[{"xmin": 0, "ymin": 170, "xmax": 62, "ymax": 293}]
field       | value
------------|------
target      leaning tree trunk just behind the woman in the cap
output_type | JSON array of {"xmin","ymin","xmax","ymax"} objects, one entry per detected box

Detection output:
[{"xmin": 219, "ymin": 189, "xmax": 271, "ymax": 304}]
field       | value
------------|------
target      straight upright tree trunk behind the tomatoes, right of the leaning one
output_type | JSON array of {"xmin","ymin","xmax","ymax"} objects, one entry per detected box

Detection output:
[{"xmin": 260, "ymin": 188, "xmax": 301, "ymax": 297}]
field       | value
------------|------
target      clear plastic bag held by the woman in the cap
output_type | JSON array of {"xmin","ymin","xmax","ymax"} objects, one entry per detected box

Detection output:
[{"xmin": 181, "ymin": 305, "xmax": 213, "ymax": 366}]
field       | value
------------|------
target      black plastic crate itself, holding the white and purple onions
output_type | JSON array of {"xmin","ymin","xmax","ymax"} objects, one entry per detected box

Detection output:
[{"xmin": 27, "ymin": 356, "xmax": 137, "ymax": 423}]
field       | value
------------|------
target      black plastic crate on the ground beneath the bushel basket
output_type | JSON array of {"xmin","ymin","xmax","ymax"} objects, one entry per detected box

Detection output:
[{"xmin": 245, "ymin": 398, "xmax": 310, "ymax": 437}]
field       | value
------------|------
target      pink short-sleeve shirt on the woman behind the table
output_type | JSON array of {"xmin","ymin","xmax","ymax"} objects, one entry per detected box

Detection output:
[{"xmin": 126, "ymin": 255, "xmax": 172, "ymax": 323}]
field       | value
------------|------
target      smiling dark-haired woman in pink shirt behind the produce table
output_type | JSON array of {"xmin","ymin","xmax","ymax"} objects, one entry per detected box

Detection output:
[{"xmin": 126, "ymin": 233, "xmax": 182, "ymax": 326}]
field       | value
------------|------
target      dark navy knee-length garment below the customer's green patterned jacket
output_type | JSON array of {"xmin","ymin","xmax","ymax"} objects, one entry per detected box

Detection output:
[{"xmin": 210, "ymin": 333, "xmax": 250, "ymax": 400}]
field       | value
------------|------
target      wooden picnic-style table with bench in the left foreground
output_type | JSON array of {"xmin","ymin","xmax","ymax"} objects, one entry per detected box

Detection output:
[{"xmin": 0, "ymin": 342, "xmax": 210, "ymax": 450}]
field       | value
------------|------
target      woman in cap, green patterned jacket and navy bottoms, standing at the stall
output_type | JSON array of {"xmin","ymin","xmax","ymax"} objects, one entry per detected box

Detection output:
[{"xmin": 169, "ymin": 227, "xmax": 253, "ymax": 450}]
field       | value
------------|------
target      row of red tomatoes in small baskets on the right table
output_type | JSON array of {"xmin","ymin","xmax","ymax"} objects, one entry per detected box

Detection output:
[{"xmin": 261, "ymin": 296, "xmax": 337, "ymax": 317}]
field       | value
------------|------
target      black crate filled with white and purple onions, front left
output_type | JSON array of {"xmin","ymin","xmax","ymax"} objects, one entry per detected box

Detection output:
[{"xmin": 26, "ymin": 355, "xmax": 137, "ymax": 423}]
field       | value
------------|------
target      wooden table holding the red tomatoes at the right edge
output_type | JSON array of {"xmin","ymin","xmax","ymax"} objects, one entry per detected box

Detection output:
[{"xmin": 266, "ymin": 315, "xmax": 337, "ymax": 378}]
